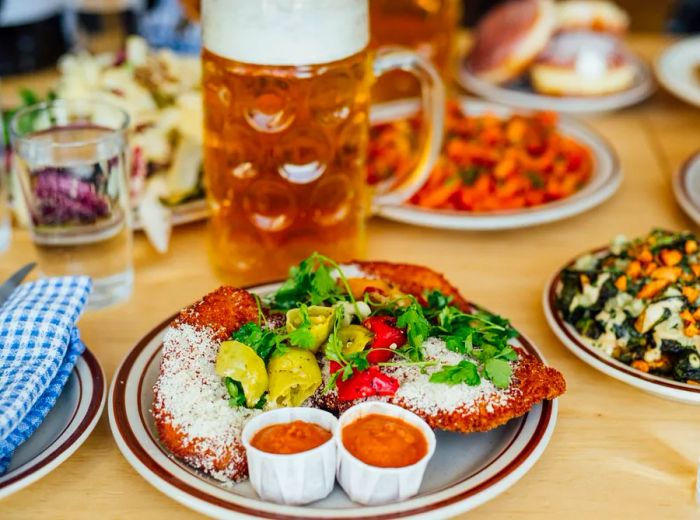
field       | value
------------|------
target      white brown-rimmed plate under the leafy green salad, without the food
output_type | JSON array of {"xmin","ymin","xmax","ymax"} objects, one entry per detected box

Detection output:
[{"xmin": 542, "ymin": 253, "xmax": 700, "ymax": 405}]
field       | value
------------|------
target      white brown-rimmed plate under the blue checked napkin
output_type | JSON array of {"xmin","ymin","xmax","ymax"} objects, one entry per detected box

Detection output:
[{"xmin": 0, "ymin": 350, "xmax": 106, "ymax": 500}]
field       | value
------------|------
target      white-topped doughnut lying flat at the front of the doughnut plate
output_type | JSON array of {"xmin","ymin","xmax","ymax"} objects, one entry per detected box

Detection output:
[{"xmin": 530, "ymin": 31, "xmax": 636, "ymax": 96}]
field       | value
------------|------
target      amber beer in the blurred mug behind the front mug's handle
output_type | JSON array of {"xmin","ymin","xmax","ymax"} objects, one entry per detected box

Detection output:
[{"xmin": 369, "ymin": 0, "xmax": 462, "ymax": 100}]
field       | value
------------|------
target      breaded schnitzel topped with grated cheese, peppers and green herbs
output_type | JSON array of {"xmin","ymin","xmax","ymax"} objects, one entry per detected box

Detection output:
[{"xmin": 152, "ymin": 255, "xmax": 565, "ymax": 481}]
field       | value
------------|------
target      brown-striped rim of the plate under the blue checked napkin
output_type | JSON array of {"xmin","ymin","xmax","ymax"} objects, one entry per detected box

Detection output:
[{"xmin": 0, "ymin": 348, "xmax": 107, "ymax": 498}]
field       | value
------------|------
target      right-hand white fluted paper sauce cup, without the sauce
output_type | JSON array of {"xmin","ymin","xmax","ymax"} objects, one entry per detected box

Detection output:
[{"xmin": 335, "ymin": 402, "xmax": 435, "ymax": 505}]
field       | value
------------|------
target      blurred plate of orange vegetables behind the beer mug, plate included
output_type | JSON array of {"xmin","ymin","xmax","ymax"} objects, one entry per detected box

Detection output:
[{"xmin": 368, "ymin": 97, "xmax": 622, "ymax": 230}]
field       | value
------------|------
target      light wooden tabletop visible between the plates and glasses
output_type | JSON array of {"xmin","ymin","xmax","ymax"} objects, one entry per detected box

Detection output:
[{"xmin": 0, "ymin": 35, "xmax": 700, "ymax": 520}]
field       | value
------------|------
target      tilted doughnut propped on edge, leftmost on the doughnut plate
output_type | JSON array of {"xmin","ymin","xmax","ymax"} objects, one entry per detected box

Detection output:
[{"xmin": 467, "ymin": 0, "xmax": 556, "ymax": 84}]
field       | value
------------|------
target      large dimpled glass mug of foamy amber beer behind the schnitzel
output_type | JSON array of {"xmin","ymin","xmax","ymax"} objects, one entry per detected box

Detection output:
[{"xmin": 202, "ymin": 0, "xmax": 444, "ymax": 283}]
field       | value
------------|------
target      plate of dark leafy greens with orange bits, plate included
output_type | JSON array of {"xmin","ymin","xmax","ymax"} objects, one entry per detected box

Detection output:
[{"xmin": 543, "ymin": 229, "xmax": 700, "ymax": 405}]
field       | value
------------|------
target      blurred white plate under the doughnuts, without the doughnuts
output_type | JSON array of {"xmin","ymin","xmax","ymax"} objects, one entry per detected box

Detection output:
[{"xmin": 457, "ymin": 55, "xmax": 655, "ymax": 114}]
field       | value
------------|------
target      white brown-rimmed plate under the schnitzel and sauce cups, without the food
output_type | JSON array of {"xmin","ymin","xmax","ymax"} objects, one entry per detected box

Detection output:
[{"xmin": 108, "ymin": 284, "xmax": 557, "ymax": 520}]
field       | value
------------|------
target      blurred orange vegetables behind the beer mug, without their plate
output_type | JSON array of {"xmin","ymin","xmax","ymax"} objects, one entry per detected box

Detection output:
[{"xmin": 369, "ymin": 101, "xmax": 593, "ymax": 212}]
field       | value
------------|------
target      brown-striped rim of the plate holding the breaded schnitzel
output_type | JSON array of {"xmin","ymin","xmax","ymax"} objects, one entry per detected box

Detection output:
[{"xmin": 108, "ymin": 285, "xmax": 558, "ymax": 519}]
